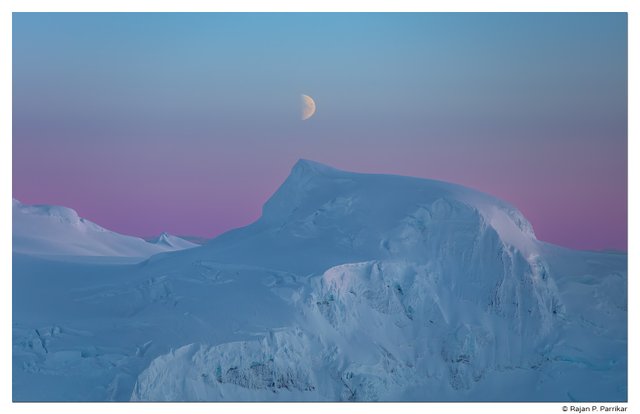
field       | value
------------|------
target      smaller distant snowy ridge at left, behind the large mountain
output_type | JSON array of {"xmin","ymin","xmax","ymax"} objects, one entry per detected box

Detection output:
[{"xmin": 13, "ymin": 199, "xmax": 196, "ymax": 257}]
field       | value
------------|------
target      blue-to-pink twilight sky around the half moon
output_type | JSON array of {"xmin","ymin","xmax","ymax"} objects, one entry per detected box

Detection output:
[{"xmin": 12, "ymin": 13, "xmax": 627, "ymax": 250}]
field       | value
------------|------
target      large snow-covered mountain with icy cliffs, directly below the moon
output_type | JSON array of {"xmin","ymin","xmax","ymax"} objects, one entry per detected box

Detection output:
[{"xmin": 14, "ymin": 160, "xmax": 627, "ymax": 401}]
